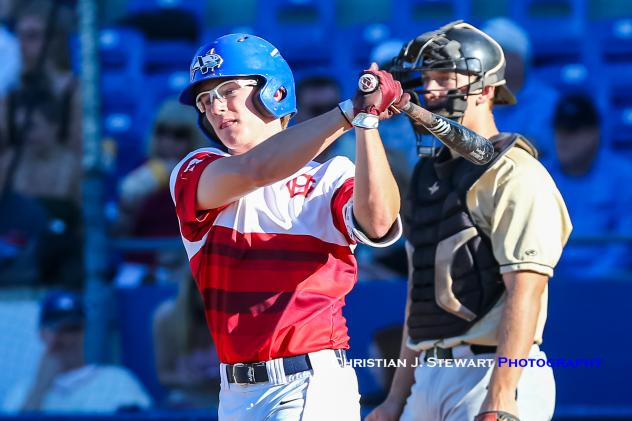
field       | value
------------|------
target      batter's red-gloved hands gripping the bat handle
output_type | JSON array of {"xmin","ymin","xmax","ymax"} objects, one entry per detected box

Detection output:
[{"xmin": 353, "ymin": 63, "xmax": 403, "ymax": 119}]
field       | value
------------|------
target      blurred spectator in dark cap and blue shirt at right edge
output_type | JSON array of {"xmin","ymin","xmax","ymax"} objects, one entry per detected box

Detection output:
[{"xmin": 550, "ymin": 95, "xmax": 632, "ymax": 280}]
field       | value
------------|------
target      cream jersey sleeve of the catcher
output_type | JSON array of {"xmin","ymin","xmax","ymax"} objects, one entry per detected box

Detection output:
[{"xmin": 468, "ymin": 150, "xmax": 572, "ymax": 276}]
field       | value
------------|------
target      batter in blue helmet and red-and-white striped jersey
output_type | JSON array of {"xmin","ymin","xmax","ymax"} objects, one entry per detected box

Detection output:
[{"xmin": 170, "ymin": 34, "xmax": 402, "ymax": 421}]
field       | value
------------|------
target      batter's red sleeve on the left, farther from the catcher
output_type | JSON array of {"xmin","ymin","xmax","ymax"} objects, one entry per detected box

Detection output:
[{"xmin": 169, "ymin": 150, "xmax": 230, "ymax": 241}]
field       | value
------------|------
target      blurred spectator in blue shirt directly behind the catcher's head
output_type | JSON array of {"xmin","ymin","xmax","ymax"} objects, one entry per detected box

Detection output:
[{"xmin": 481, "ymin": 17, "xmax": 559, "ymax": 162}]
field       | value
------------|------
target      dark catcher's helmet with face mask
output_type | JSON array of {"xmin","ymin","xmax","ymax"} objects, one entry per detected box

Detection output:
[{"xmin": 390, "ymin": 21, "xmax": 516, "ymax": 156}]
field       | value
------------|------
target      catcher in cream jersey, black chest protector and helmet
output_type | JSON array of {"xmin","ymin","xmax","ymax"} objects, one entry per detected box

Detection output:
[{"xmin": 367, "ymin": 22, "xmax": 571, "ymax": 421}]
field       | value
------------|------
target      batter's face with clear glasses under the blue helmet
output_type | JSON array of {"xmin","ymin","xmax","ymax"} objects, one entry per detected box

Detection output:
[{"xmin": 197, "ymin": 78, "xmax": 281, "ymax": 154}]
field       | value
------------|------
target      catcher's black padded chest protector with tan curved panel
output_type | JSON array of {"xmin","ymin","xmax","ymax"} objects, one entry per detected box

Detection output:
[{"xmin": 403, "ymin": 133, "xmax": 537, "ymax": 343}]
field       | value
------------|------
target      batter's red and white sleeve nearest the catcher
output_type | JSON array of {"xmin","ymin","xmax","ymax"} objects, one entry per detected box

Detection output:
[{"xmin": 331, "ymin": 158, "xmax": 402, "ymax": 247}]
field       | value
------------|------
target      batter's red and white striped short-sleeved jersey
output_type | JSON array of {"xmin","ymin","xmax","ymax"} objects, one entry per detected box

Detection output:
[{"xmin": 170, "ymin": 148, "xmax": 401, "ymax": 364}]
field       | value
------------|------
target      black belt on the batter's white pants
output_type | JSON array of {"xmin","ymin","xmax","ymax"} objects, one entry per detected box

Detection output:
[{"xmin": 226, "ymin": 349, "xmax": 347, "ymax": 384}]
